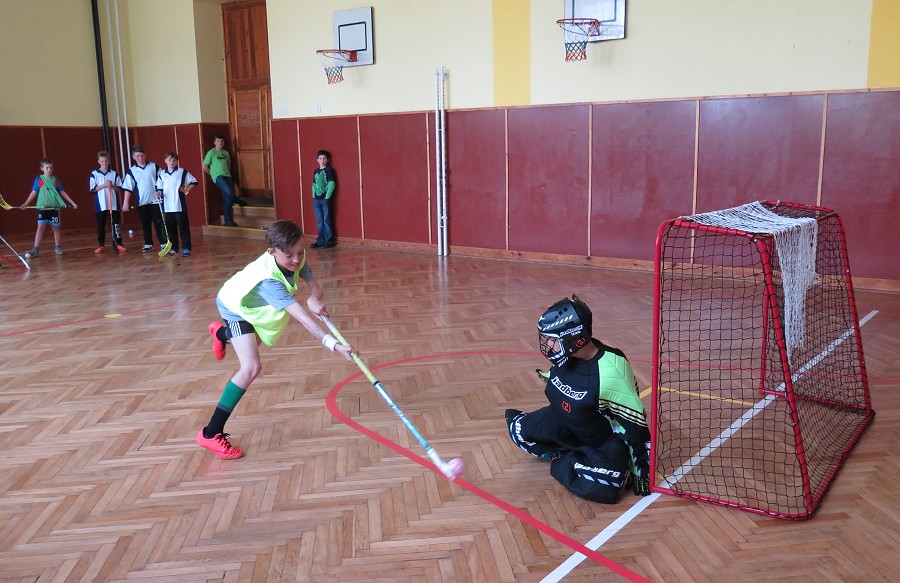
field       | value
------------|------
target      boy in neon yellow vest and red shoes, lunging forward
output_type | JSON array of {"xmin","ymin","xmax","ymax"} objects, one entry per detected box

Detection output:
[{"xmin": 197, "ymin": 221, "xmax": 356, "ymax": 459}]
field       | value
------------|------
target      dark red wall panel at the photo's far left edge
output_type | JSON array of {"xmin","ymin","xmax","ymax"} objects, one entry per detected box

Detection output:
[{"xmin": 0, "ymin": 126, "xmax": 44, "ymax": 236}]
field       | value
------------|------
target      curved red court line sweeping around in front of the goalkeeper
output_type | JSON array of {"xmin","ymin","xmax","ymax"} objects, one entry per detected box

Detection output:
[{"xmin": 325, "ymin": 350, "xmax": 651, "ymax": 583}]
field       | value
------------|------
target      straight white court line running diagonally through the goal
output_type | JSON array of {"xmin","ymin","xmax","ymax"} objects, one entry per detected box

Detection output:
[{"xmin": 541, "ymin": 310, "xmax": 878, "ymax": 583}]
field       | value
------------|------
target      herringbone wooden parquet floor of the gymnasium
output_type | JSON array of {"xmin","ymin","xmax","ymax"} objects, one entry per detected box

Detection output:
[{"xmin": 0, "ymin": 230, "xmax": 900, "ymax": 583}]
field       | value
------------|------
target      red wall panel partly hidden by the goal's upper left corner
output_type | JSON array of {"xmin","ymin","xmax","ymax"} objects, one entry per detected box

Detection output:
[{"xmin": 591, "ymin": 101, "xmax": 696, "ymax": 261}]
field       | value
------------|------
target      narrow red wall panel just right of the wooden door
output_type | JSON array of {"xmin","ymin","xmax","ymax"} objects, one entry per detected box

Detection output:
[{"xmin": 272, "ymin": 119, "xmax": 302, "ymax": 227}]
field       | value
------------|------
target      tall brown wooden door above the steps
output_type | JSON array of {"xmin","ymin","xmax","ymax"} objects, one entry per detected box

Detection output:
[{"xmin": 222, "ymin": 0, "xmax": 273, "ymax": 200}]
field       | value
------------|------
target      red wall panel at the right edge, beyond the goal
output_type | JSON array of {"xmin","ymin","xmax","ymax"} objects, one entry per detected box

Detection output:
[{"xmin": 822, "ymin": 91, "xmax": 900, "ymax": 280}]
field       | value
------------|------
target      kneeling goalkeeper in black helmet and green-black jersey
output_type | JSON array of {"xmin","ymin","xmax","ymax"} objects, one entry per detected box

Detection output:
[{"xmin": 506, "ymin": 294, "xmax": 650, "ymax": 504}]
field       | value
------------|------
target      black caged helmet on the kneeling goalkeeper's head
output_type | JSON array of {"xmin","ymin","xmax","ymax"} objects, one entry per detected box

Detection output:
[{"xmin": 538, "ymin": 294, "xmax": 592, "ymax": 366}]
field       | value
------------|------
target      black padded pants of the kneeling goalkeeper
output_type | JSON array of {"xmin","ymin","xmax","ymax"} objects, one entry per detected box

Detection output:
[{"xmin": 506, "ymin": 405, "xmax": 631, "ymax": 504}]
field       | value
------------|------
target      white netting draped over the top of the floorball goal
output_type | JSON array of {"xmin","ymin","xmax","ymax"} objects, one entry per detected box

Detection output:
[{"xmin": 684, "ymin": 202, "xmax": 819, "ymax": 363}]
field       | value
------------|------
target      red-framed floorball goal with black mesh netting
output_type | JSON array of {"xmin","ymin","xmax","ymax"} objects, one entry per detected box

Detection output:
[{"xmin": 651, "ymin": 201, "xmax": 875, "ymax": 520}]
